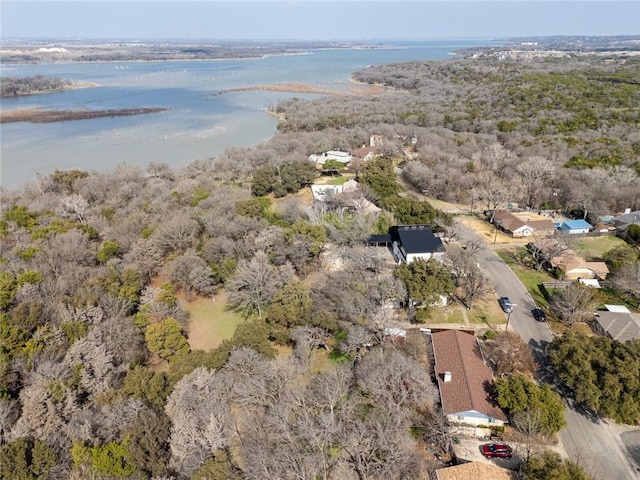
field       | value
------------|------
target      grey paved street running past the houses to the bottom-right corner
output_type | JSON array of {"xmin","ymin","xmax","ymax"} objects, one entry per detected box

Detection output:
[{"xmin": 459, "ymin": 224, "xmax": 640, "ymax": 480}]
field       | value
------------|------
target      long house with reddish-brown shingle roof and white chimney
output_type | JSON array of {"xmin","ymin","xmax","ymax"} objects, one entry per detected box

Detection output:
[{"xmin": 431, "ymin": 330, "xmax": 507, "ymax": 426}]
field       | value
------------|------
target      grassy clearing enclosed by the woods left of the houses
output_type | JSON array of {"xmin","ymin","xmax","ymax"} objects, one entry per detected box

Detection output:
[{"xmin": 182, "ymin": 291, "xmax": 243, "ymax": 351}]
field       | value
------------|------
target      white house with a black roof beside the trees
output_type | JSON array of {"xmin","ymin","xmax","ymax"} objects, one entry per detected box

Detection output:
[{"xmin": 389, "ymin": 225, "xmax": 444, "ymax": 263}]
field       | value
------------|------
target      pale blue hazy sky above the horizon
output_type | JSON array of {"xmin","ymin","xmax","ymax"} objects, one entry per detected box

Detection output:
[{"xmin": 0, "ymin": 0, "xmax": 640, "ymax": 41}]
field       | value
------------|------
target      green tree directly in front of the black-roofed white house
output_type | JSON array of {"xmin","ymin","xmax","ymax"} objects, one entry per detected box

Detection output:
[{"xmin": 393, "ymin": 258, "xmax": 455, "ymax": 309}]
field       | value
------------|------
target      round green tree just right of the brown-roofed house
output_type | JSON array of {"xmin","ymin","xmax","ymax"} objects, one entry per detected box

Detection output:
[{"xmin": 495, "ymin": 375, "xmax": 566, "ymax": 435}]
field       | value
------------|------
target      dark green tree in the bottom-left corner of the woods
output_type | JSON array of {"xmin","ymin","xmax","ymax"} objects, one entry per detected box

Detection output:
[{"xmin": 0, "ymin": 438, "xmax": 57, "ymax": 480}]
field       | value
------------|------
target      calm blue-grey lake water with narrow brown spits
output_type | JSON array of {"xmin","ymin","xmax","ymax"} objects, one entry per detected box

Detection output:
[{"xmin": 0, "ymin": 41, "xmax": 487, "ymax": 189}]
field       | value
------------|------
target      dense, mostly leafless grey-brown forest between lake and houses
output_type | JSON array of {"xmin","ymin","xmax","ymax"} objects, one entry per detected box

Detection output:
[{"xmin": 0, "ymin": 48, "xmax": 640, "ymax": 480}]
